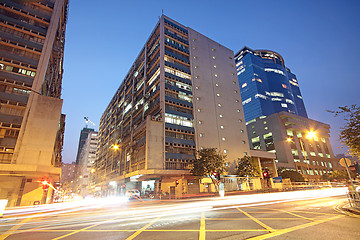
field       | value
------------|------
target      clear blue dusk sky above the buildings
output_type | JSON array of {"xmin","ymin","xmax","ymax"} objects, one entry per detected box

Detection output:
[{"xmin": 62, "ymin": 0, "xmax": 360, "ymax": 163}]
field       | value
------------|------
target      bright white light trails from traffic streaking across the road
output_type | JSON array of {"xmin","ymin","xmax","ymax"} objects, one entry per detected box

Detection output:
[{"xmin": 4, "ymin": 188, "xmax": 347, "ymax": 223}]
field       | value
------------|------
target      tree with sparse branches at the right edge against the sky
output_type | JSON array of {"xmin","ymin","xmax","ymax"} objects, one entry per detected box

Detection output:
[{"xmin": 328, "ymin": 104, "xmax": 360, "ymax": 157}]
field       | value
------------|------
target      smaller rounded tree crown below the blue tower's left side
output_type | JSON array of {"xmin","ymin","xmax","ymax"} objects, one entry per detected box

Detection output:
[{"xmin": 236, "ymin": 156, "xmax": 260, "ymax": 177}]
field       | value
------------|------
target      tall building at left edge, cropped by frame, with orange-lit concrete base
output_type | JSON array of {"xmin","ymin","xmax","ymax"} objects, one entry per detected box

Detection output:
[{"xmin": 0, "ymin": 0, "xmax": 68, "ymax": 206}]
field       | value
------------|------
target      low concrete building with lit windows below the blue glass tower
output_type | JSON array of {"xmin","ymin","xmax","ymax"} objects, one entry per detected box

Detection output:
[{"xmin": 247, "ymin": 112, "xmax": 344, "ymax": 181}]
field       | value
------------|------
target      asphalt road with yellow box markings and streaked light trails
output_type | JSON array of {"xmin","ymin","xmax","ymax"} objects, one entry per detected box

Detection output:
[{"xmin": 0, "ymin": 190, "xmax": 360, "ymax": 240}]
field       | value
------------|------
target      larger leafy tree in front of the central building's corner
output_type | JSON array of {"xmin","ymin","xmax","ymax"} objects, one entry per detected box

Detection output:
[{"xmin": 190, "ymin": 148, "xmax": 227, "ymax": 190}]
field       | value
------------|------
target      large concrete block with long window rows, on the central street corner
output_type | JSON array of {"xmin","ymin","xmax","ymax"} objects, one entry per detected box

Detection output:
[{"xmin": 95, "ymin": 16, "xmax": 270, "ymax": 198}]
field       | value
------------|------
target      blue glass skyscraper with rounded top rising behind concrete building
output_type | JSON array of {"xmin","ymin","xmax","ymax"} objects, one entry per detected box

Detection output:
[{"xmin": 235, "ymin": 47, "xmax": 307, "ymax": 121}]
